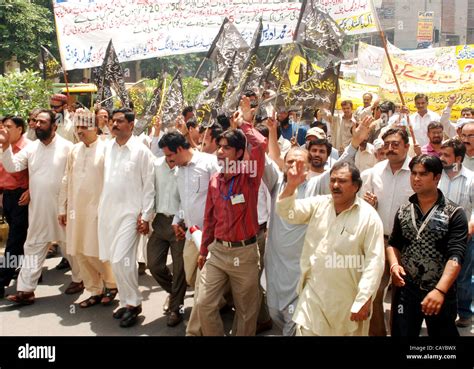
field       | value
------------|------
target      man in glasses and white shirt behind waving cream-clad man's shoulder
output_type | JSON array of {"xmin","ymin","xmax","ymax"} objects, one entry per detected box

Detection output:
[{"xmin": 361, "ymin": 128, "xmax": 413, "ymax": 336}]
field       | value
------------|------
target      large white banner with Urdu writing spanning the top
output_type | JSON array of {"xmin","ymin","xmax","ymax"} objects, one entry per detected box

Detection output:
[{"xmin": 53, "ymin": 0, "xmax": 301, "ymax": 70}]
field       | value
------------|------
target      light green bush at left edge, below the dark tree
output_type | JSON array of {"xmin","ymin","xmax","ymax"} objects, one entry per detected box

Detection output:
[{"xmin": 0, "ymin": 70, "xmax": 51, "ymax": 118}]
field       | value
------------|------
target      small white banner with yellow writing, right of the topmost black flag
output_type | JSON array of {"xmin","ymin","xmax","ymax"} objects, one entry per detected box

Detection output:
[{"xmin": 313, "ymin": 0, "xmax": 377, "ymax": 35}]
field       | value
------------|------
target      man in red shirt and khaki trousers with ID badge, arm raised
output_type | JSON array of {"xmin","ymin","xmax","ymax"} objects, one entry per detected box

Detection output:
[{"xmin": 196, "ymin": 96, "xmax": 267, "ymax": 336}]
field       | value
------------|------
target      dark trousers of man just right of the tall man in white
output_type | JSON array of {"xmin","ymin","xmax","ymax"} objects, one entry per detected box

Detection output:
[{"xmin": 147, "ymin": 213, "xmax": 186, "ymax": 312}]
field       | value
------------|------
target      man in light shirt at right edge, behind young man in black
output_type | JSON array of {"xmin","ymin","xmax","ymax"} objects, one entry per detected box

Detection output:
[{"xmin": 438, "ymin": 139, "xmax": 474, "ymax": 328}]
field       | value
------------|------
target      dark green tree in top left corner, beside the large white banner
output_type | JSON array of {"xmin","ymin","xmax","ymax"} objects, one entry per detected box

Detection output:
[{"xmin": 0, "ymin": 0, "xmax": 57, "ymax": 69}]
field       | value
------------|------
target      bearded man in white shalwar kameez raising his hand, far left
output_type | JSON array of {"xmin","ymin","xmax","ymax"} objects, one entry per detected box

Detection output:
[{"xmin": 0, "ymin": 110, "xmax": 75, "ymax": 304}]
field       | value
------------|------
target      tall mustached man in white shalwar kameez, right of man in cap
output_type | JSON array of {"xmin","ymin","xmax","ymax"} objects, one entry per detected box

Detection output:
[{"xmin": 99, "ymin": 109, "xmax": 155, "ymax": 327}]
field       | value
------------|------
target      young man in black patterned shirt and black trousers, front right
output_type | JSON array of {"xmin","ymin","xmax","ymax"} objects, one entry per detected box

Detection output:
[{"xmin": 387, "ymin": 155, "xmax": 468, "ymax": 336}]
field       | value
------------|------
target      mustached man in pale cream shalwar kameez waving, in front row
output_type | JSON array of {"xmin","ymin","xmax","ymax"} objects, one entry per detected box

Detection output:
[{"xmin": 276, "ymin": 160, "xmax": 385, "ymax": 336}]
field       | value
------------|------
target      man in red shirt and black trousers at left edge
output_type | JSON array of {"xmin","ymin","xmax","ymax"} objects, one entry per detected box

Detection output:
[{"xmin": 0, "ymin": 116, "xmax": 30, "ymax": 297}]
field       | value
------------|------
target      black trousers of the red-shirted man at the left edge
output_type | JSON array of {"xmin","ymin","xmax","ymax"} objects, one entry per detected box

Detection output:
[{"xmin": 0, "ymin": 188, "xmax": 28, "ymax": 287}]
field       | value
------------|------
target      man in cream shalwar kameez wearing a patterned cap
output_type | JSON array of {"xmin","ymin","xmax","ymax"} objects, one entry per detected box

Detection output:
[{"xmin": 59, "ymin": 111, "xmax": 117, "ymax": 308}]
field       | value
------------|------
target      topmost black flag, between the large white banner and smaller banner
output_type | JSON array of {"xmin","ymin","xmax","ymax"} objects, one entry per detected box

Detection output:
[{"xmin": 295, "ymin": 0, "xmax": 344, "ymax": 59}]
